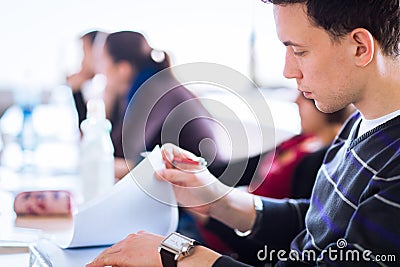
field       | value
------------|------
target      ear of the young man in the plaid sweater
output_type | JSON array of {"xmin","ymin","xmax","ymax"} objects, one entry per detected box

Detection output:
[{"xmin": 350, "ymin": 28, "xmax": 375, "ymax": 67}]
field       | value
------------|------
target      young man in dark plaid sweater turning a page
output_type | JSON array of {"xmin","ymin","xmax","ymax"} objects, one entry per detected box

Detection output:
[{"xmin": 88, "ymin": 0, "xmax": 400, "ymax": 267}]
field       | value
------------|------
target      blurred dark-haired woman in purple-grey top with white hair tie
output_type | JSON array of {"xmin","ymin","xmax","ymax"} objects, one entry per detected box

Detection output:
[{"xmin": 103, "ymin": 31, "xmax": 223, "ymax": 178}]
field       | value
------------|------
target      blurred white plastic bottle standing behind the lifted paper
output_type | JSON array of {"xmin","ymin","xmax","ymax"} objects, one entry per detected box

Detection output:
[{"xmin": 80, "ymin": 99, "xmax": 114, "ymax": 202}]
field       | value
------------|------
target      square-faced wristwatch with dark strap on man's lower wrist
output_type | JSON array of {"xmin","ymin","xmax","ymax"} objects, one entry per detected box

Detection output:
[{"xmin": 158, "ymin": 232, "xmax": 200, "ymax": 267}]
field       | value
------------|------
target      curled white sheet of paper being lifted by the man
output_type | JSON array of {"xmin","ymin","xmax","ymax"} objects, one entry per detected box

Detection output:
[{"xmin": 54, "ymin": 146, "xmax": 178, "ymax": 248}]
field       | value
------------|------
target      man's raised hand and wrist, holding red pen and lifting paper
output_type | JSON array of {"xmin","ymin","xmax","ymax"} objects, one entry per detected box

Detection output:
[{"xmin": 156, "ymin": 144, "xmax": 256, "ymax": 234}]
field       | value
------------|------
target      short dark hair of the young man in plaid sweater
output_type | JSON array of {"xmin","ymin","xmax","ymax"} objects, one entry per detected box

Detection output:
[{"xmin": 263, "ymin": 0, "xmax": 400, "ymax": 57}]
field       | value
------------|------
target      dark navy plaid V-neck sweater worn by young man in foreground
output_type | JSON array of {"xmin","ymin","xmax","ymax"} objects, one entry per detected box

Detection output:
[{"xmin": 213, "ymin": 113, "xmax": 400, "ymax": 267}]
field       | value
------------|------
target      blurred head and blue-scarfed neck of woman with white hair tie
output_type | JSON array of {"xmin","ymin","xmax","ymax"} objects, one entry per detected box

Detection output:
[{"xmin": 103, "ymin": 31, "xmax": 170, "ymax": 125}]
